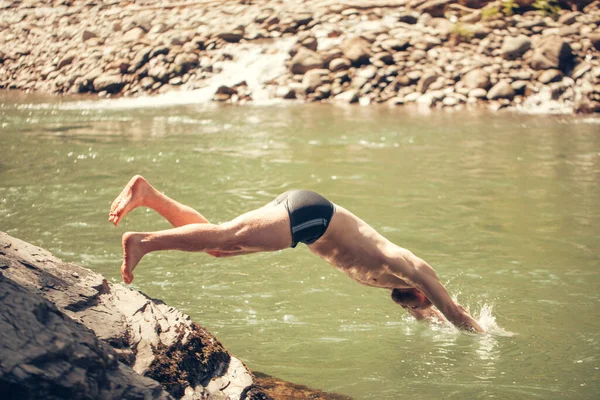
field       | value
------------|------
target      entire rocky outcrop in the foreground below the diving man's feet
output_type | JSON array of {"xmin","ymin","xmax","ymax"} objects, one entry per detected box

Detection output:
[{"xmin": 0, "ymin": 232, "xmax": 348, "ymax": 400}]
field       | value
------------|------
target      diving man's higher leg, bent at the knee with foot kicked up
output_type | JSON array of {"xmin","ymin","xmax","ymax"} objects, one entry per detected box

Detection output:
[{"xmin": 108, "ymin": 175, "xmax": 208, "ymax": 227}]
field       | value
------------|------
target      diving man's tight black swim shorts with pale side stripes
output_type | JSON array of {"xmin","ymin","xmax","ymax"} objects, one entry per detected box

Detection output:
[{"xmin": 273, "ymin": 190, "xmax": 335, "ymax": 247}]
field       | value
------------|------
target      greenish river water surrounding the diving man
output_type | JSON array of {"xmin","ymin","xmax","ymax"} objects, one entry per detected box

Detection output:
[{"xmin": 0, "ymin": 94, "xmax": 600, "ymax": 399}]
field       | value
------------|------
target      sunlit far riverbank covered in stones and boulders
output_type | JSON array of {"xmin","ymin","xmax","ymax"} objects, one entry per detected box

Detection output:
[{"xmin": 0, "ymin": 0, "xmax": 600, "ymax": 112}]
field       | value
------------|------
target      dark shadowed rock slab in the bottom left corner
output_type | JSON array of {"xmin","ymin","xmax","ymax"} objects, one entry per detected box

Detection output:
[{"xmin": 0, "ymin": 276, "xmax": 171, "ymax": 400}]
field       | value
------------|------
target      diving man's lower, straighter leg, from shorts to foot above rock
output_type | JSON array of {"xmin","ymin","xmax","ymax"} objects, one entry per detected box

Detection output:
[{"xmin": 121, "ymin": 200, "xmax": 292, "ymax": 283}]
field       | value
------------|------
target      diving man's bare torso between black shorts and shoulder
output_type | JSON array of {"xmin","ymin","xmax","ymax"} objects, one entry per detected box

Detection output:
[{"xmin": 308, "ymin": 204, "xmax": 411, "ymax": 289}]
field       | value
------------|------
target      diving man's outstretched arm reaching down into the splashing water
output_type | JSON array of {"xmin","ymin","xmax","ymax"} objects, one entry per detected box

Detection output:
[{"xmin": 388, "ymin": 250, "xmax": 485, "ymax": 332}]
